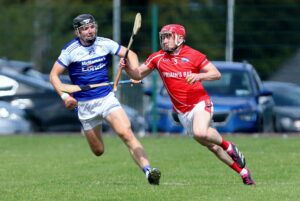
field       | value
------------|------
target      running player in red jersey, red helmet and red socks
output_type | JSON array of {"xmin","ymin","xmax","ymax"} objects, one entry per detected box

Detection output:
[{"xmin": 120, "ymin": 24, "xmax": 255, "ymax": 185}]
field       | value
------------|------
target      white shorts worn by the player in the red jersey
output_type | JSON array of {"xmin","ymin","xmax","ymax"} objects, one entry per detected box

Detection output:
[{"xmin": 178, "ymin": 99, "xmax": 214, "ymax": 134}]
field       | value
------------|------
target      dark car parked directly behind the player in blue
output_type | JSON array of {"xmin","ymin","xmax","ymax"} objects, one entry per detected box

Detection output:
[{"xmin": 0, "ymin": 68, "xmax": 145, "ymax": 135}]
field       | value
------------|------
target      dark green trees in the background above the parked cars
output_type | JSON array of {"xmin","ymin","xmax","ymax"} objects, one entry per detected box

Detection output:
[{"xmin": 0, "ymin": 0, "xmax": 300, "ymax": 79}]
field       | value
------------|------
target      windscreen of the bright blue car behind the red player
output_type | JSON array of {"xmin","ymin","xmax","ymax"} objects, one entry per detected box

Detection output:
[{"xmin": 202, "ymin": 70, "xmax": 253, "ymax": 97}]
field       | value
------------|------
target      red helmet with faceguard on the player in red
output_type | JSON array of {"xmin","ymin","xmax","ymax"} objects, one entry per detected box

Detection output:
[{"xmin": 159, "ymin": 24, "xmax": 186, "ymax": 52}]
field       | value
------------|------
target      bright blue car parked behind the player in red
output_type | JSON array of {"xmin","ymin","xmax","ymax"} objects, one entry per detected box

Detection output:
[{"xmin": 145, "ymin": 61, "xmax": 274, "ymax": 133}]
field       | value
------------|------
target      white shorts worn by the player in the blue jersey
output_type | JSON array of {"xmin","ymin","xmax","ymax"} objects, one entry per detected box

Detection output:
[{"xmin": 78, "ymin": 92, "xmax": 121, "ymax": 130}]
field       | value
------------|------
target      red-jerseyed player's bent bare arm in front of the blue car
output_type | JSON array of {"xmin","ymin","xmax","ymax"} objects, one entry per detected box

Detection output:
[{"xmin": 186, "ymin": 62, "xmax": 221, "ymax": 84}]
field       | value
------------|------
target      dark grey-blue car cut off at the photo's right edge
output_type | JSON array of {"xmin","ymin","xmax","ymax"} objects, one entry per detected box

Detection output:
[{"xmin": 263, "ymin": 81, "xmax": 300, "ymax": 132}]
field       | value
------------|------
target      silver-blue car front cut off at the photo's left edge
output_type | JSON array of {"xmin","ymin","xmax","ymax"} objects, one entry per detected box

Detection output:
[{"xmin": 0, "ymin": 101, "xmax": 33, "ymax": 135}]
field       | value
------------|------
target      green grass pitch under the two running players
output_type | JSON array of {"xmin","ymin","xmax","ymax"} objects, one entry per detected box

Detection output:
[{"xmin": 0, "ymin": 135, "xmax": 300, "ymax": 201}]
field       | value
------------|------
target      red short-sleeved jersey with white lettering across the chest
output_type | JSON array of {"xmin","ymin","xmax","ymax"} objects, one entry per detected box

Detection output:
[{"xmin": 144, "ymin": 45, "xmax": 209, "ymax": 113}]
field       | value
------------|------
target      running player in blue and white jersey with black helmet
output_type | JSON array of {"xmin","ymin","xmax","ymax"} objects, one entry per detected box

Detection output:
[{"xmin": 50, "ymin": 14, "xmax": 161, "ymax": 185}]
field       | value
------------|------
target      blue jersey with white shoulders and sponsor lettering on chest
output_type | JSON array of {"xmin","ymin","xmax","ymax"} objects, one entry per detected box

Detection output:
[{"xmin": 57, "ymin": 37, "xmax": 121, "ymax": 101}]
